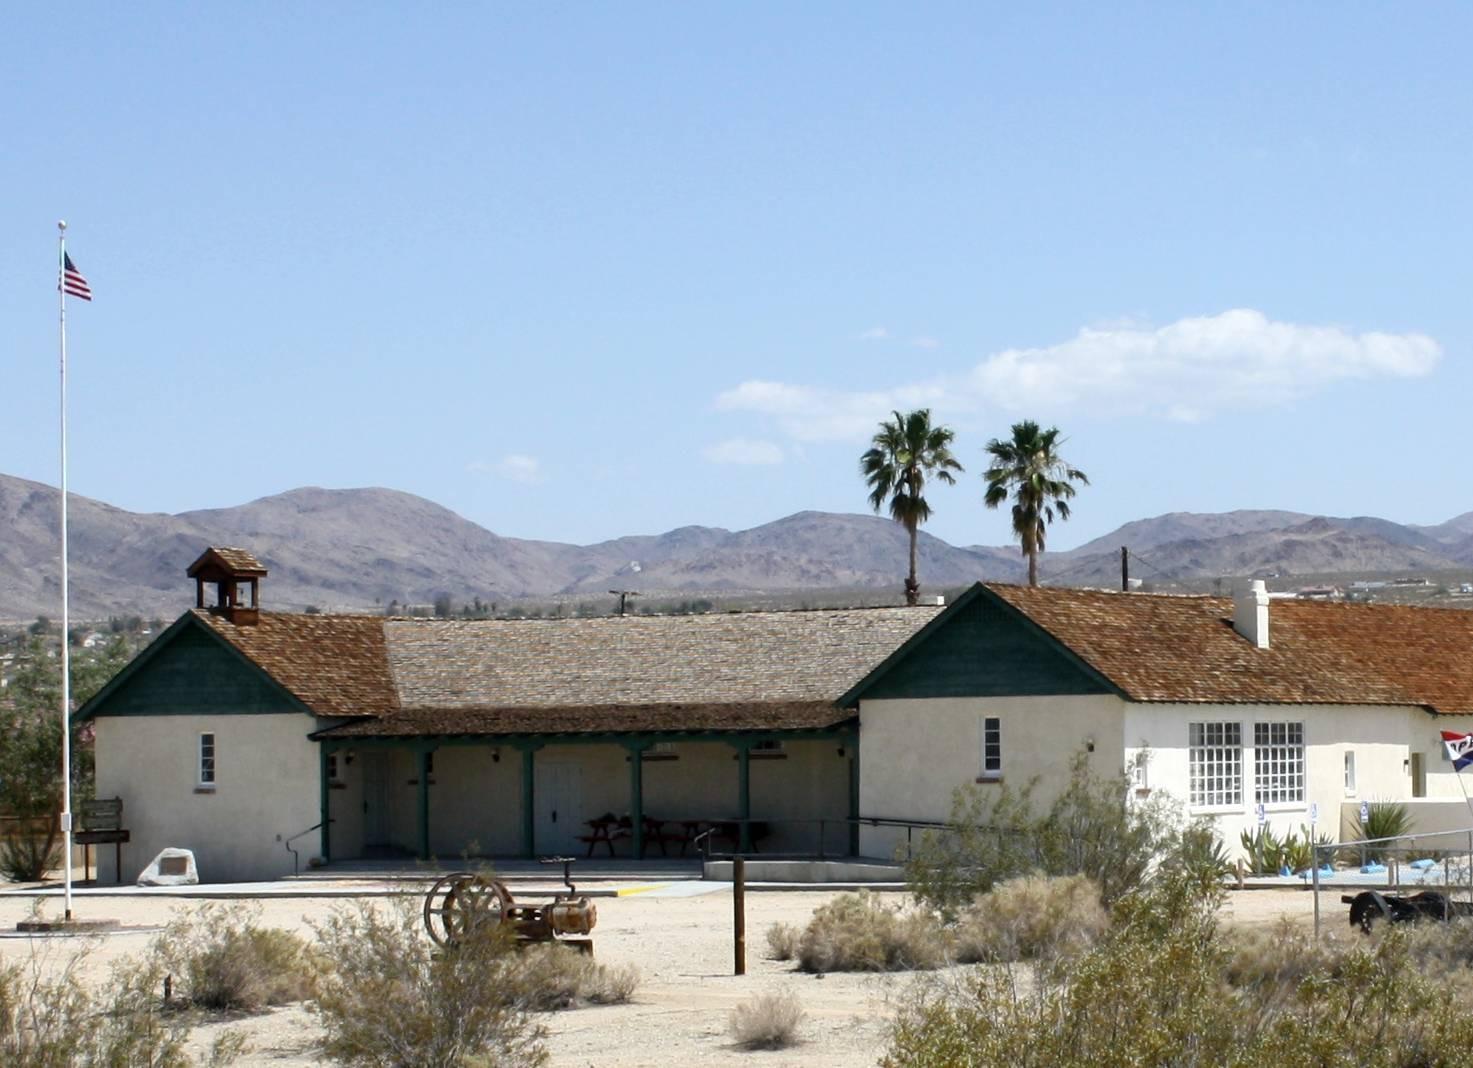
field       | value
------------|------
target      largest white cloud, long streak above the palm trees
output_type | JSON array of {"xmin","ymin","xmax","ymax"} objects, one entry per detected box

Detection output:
[{"xmin": 716, "ymin": 308, "xmax": 1442, "ymax": 440}]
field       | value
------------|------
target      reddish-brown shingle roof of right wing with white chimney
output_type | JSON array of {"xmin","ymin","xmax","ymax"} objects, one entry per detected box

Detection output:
[{"xmin": 990, "ymin": 586, "xmax": 1473, "ymax": 713}]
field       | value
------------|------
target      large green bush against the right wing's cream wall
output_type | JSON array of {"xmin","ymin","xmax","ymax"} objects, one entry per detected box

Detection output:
[{"xmin": 906, "ymin": 751, "xmax": 1180, "ymax": 921}]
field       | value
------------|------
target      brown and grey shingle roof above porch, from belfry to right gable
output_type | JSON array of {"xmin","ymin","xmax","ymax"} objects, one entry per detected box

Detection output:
[{"xmin": 196, "ymin": 607, "xmax": 940, "ymax": 735}]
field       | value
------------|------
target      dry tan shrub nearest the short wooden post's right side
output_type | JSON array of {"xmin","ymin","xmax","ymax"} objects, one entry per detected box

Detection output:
[{"xmin": 798, "ymin": 890, "xmax": 949, "ymax": 972}]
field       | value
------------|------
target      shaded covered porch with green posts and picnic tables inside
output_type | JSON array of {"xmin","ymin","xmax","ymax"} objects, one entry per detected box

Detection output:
[{"xmin": 315, "ymin": 722, "xmax": 859, "ymax": 863}]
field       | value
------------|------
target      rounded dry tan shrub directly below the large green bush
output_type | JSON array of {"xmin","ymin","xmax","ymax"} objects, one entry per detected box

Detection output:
[{"xmin": 956, "ymin": 875, "xmax": 1109, "ymax": 963}]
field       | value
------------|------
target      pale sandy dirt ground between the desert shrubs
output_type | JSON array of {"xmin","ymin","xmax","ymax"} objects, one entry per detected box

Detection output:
[{"xmin": 0, "ymin": 890, "xmax": 1325, "ymax": 1068}]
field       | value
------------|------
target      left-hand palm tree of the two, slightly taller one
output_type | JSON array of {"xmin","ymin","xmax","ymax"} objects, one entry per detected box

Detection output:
[{"xmin": 859, "ymin": 408, "xmax": 962, "ymax": 604}]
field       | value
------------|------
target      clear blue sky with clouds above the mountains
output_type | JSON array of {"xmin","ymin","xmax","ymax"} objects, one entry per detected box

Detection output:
[{"xmin": 0, "ymin": 10, "xmax": 1473, "ymax": 548}]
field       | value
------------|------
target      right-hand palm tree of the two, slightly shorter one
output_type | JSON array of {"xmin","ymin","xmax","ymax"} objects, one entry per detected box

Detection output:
[{"xmin": 982, "ymin": 420, "xmax": 1090, "ymax": 586}]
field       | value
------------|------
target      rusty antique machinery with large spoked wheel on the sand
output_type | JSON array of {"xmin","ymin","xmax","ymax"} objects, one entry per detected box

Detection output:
[{"xmin": 424, "ymin": 857, "xmax": 598, "ymax": 953}]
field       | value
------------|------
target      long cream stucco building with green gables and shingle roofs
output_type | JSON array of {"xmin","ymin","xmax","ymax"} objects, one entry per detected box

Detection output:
[{"xmin": 80, "ymin": 549, "xmax": 1473, "ymax": 879}]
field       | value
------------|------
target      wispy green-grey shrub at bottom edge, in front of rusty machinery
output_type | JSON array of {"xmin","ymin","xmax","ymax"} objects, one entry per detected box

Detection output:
[{"xmin": 314, "ymin": 899, "xmax": 546, "ymax": 1068}]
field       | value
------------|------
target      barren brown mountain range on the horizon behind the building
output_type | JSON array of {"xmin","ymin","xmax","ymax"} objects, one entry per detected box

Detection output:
[{"xmin": 0, "ymin": 474, "xmax": 1473, "ymax": 620}]
